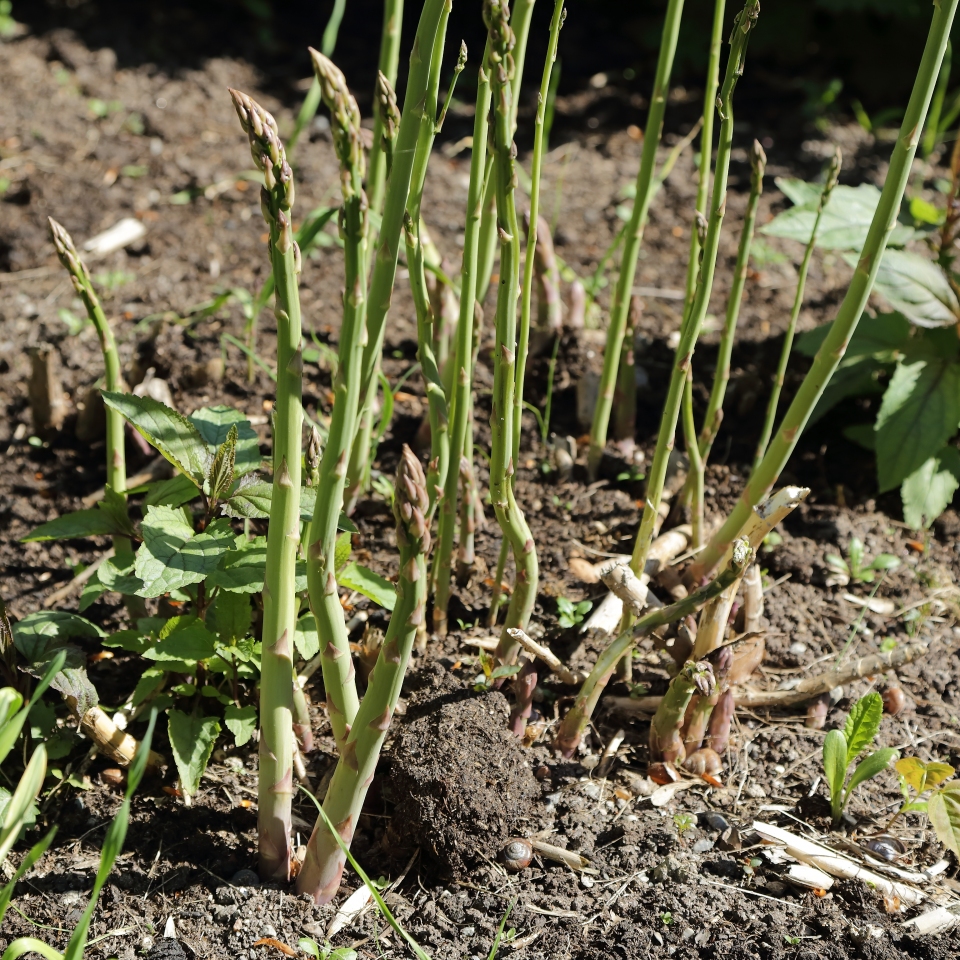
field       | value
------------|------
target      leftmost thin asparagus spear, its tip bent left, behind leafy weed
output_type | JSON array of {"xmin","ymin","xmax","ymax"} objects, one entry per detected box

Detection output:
[{"xmin": 47, "ymin": 217, "xmax": 130, "ymax": 512}]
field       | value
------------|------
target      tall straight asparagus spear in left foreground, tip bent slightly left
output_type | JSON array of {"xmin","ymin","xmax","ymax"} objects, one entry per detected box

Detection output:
[{"xmin": 230, "ymin": 90, "xmax": 303, "ymax": 881}]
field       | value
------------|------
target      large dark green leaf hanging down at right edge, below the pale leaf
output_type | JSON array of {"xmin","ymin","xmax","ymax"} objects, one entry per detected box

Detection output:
[{"xmin": 876, "ymin": 355, "xmax": 960, "ymax": 493}]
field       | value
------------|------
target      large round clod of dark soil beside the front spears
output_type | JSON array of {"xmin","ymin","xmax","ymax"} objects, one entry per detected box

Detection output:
[{"xmin": 389, "ymin": 664, "xmax": 540, "ymax": 876}]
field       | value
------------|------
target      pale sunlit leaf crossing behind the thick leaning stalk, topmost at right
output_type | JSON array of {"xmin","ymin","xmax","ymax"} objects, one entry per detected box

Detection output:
[{"xmin": 760, "ymin": 183, "xmax": 916, "ymax": 251}]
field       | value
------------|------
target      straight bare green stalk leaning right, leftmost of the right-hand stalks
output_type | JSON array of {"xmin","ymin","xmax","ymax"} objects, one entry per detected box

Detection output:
[{"xmin": 588, "ymin": 0, "xmax": 683, "ymax": 479}]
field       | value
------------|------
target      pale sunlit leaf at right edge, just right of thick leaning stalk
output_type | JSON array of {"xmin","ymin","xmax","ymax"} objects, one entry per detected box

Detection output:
[{"xmin": 864, "ymin": 250, "xmax": 960, "ymax": 327}]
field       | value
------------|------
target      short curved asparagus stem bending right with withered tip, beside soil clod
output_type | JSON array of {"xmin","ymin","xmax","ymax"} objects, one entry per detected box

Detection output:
[{"xmin": 556, "ymin": 541, "xmax": 752, "ymax": 757}]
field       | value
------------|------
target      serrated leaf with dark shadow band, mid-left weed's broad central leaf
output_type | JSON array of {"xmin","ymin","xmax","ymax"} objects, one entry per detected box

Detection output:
[{"xmin": 135, "ymin": 507, "xmax": 234, "ymax": 597}]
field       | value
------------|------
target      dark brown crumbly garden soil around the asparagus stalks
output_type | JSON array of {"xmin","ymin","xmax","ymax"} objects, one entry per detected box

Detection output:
[{"xmin": 0, "ymin": 18, "xmax": 960, "ymax": 960}]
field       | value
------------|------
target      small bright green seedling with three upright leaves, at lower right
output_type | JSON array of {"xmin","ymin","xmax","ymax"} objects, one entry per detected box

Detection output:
[{"xmin": 823, "ymin": 692, "xmax": 899, "ymax": 826}]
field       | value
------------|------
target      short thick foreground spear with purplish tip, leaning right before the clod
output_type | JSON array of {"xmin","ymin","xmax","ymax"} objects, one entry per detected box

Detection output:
[{"xmin": 297, "ymin": 446, "xmax": 430, "ymax": 904}]
